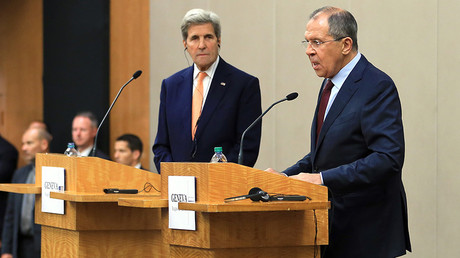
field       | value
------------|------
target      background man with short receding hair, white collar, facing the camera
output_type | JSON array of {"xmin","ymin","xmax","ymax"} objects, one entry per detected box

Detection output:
[{"xmin": 72, "ymin": 112, "xmax": 110, "ymax": 160}]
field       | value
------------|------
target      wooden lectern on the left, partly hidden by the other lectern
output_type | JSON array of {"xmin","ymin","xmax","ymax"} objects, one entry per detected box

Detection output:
[{"xmin": 0, "ymin": 154, "xmax": 162, "ymax": 257}]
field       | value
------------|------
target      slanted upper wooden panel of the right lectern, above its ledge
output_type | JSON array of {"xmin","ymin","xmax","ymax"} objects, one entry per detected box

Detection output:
[{"xmin": 161, "ymin": 162, "xmax": 327, "ymax": 203}]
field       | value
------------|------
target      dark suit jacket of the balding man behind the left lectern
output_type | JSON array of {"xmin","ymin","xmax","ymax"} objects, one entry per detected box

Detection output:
[{"xmin": 2, "ymin": 164, "xmax": 41, "ymax": 257}]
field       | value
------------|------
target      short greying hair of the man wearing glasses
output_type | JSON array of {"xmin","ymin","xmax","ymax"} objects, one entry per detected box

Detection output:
[{"xmin": 310, "ymin": 6, "xmax": 358, "ymax": 51}]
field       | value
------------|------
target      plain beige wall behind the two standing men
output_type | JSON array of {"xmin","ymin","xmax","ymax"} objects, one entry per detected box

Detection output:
[{"xmin": 150, "ymin": 0, "xmax": 460, "ymax": 257}]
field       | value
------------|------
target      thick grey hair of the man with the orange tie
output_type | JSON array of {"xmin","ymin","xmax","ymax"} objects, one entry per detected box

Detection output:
[{"xmin": 180, "ymin": 9, "xmax": 220, "ymax": 40}]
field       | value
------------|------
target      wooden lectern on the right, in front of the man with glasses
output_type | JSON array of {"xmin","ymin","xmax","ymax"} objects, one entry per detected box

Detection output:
[{"xmin": 161, "ymin": 163, "xmax": 330, "ymax": 257}]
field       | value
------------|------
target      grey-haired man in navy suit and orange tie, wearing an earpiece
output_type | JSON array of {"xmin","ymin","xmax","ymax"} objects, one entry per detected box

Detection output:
[{"xmin": 152, "ymin": 9, "xmax": 261, "ymax": 172}]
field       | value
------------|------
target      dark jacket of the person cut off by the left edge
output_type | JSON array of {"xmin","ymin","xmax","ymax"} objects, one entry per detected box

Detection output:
[{"xmin": 0, "ymin": 136, "xmax": 18, "ymax": 237}]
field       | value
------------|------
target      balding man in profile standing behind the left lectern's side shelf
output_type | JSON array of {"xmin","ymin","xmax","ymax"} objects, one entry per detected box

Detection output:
[{"xmin": 2, "ymin": 128, "xmax": 52, "ymax": 258}]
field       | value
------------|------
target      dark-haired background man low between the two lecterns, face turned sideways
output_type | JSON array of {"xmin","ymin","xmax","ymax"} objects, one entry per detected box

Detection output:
[{"xmin": 113, "ymin": 134, "xmax": 145, "ymax": 170}]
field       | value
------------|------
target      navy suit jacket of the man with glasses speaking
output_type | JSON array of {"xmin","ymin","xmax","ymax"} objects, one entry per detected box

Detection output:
[{"xmin": 284, "ymin": 56, "xmax": 411, "ymax": 257}]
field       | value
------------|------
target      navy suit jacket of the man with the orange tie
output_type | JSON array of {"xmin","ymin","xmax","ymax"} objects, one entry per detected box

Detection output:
[{"xmin": 152, "ymin": 58, "xmax": 261, "ymax": 171}]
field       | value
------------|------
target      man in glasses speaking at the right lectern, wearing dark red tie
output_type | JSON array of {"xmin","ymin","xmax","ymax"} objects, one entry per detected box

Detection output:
[{"xmin": 267, "ymin": 7, "xmax": 411, "ymax": 258}]
